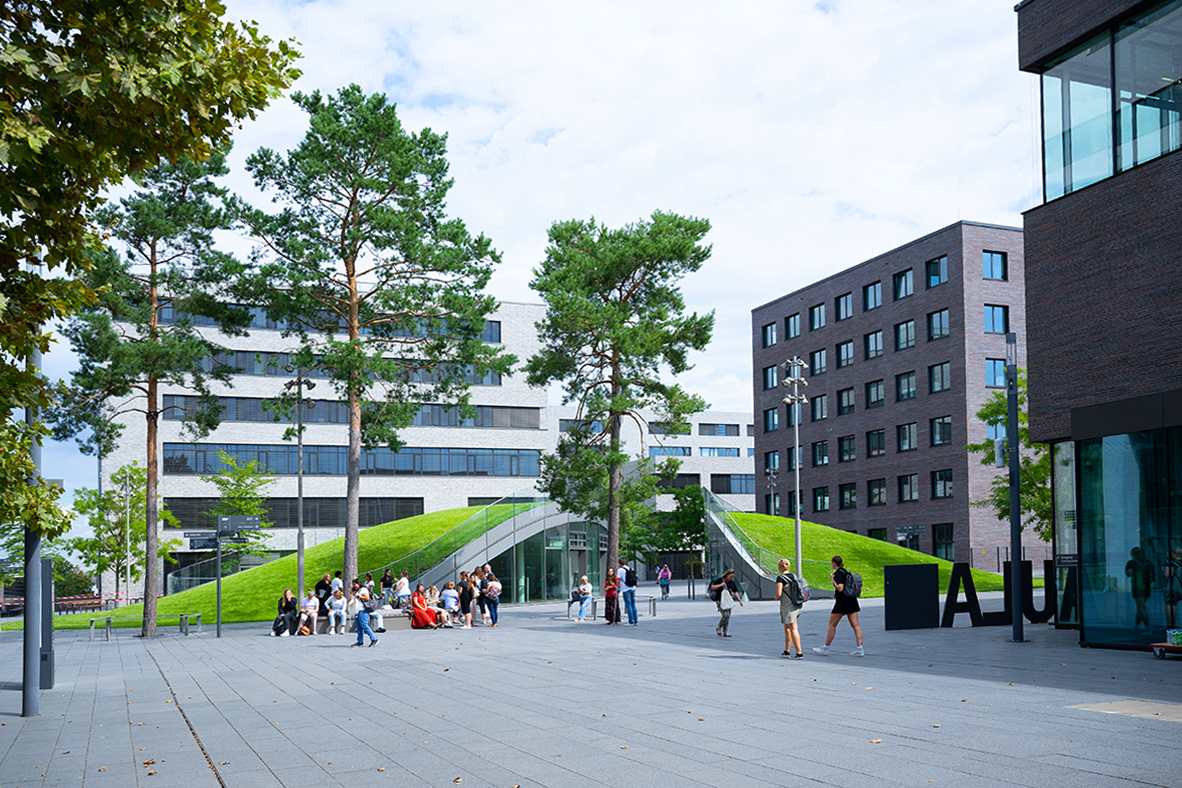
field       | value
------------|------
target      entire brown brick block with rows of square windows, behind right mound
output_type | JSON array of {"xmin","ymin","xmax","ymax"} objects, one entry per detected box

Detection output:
[{"xmin": 752, "ymin": 222, "xmax": 1043, "ymax": 569}]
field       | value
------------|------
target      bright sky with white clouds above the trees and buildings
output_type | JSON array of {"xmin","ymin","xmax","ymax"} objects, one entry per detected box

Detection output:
[{"xmin": 36, "ymin": 0, "xmax": 1038, "ymax": 533}]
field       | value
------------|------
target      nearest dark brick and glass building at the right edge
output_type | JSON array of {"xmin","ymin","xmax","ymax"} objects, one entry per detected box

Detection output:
[{"xmin": 1017, "ymin": 0, "xmax": 1182, "ymax": 647}]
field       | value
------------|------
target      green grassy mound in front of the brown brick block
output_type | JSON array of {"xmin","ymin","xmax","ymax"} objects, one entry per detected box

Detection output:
[{"xmin": 732, "ymin": 513, "xmax": 1002, "ymax": 597}]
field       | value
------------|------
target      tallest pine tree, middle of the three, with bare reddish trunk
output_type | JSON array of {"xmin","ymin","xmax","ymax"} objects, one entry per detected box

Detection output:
[{"xmin": 236, "ymin": 85, "xmax": 514, "ymax": 578}]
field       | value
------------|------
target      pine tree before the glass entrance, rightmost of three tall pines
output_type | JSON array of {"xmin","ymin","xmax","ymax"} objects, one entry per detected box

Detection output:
[{"xmin": 526, "ymin": 210, "xmax": 714, "ymax": 566}]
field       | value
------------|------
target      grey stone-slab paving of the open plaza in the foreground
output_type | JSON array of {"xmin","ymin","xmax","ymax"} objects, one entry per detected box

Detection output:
[{"xmin": 0, "ymin": 590, "xmax": 1182, "ymax": 788}]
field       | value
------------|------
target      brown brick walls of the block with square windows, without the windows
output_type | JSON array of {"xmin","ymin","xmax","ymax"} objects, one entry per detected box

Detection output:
[{"xmin": 752, "ymin": 222, "xmax": 1026, "ymax": 567}]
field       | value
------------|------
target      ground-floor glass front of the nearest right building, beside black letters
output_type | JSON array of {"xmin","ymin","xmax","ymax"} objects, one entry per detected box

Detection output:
[{"xmin": 1077, "ymin": 426, "xmax": 1182, "ymax": 645}]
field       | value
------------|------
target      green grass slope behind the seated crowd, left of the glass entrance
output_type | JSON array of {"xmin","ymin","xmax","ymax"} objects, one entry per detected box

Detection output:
[{"xmin": 4, "ymin": 504, "xmax": 498, "ymax": 630}]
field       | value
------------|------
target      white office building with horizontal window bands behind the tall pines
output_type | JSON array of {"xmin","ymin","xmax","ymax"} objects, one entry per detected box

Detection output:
[{"xmin": 103, "ymin": 302, "xmax": 754, "ymax": 593}]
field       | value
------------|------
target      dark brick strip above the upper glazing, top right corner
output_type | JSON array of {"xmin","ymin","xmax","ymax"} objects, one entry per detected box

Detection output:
[{"xmin": 1018, "ymin": 0, "xmax": 1155, "ymax": 71}]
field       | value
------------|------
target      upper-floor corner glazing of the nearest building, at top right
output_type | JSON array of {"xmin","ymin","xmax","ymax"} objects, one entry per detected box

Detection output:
[{"xmin": 1043, "ymin": 0, "xmax": 1182, "ymax": 200}]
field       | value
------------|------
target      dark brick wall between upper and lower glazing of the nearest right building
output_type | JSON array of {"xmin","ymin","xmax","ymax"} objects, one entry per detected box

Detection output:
[{"xmin": 1025, "ymin": 147, "xmax": 1182, "ymax": 442}]
